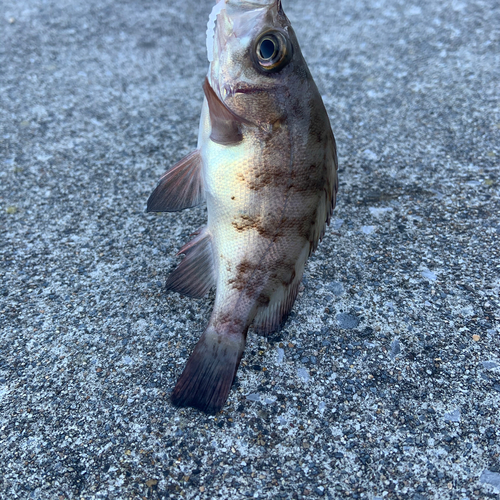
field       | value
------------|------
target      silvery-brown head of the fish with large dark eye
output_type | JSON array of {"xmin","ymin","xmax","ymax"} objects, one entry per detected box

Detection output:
[{"xmin": 207, "ymin": 0, "xmax": 308, "ymax": 124}]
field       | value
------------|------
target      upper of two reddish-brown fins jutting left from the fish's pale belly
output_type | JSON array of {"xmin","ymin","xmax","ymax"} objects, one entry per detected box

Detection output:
[{"xmin": 146, "ymin": 149, "xmax": 205, "ymax": 212}]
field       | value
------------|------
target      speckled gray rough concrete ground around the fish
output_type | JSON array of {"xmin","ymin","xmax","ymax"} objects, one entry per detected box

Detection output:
[{"xmin": 0, "ymin": 0, "xmax": 500, "ymax": 500}]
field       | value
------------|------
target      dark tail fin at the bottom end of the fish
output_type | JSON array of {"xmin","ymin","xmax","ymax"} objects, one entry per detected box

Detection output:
[{"xmin": 171, "ymin": 325, "xmax": 248, "ymax": 414}]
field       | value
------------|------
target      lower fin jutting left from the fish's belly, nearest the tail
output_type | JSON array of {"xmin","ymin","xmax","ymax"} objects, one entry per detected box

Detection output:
[{"xmin": 166, "ymin": 227, "xmax": 215, "ymax": 298}]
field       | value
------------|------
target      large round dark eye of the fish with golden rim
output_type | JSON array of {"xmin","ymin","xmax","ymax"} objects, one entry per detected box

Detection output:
[{"xmin": 253, "ymin": 30, "xmax": 292, "ymax": 73}]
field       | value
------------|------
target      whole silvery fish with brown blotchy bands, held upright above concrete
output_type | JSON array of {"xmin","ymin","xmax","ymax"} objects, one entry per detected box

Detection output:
[{"xmin": 147, "ymin": 0, "xmax": 338, "ymax": 414}]
